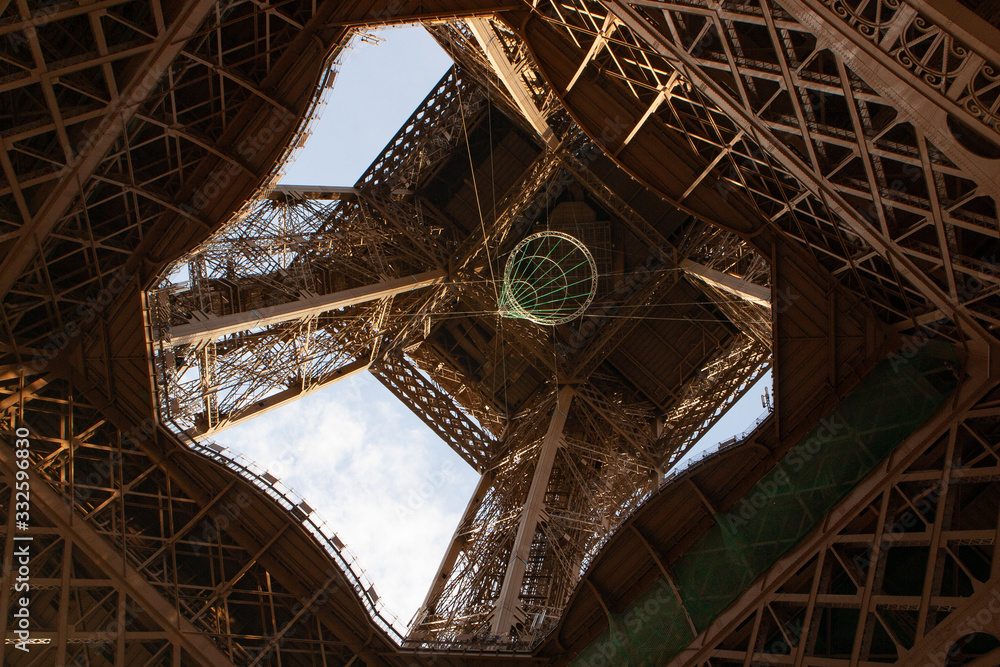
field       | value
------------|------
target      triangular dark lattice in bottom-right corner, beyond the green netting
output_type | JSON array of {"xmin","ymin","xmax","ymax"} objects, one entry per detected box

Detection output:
[{"xmin": 670, "ymin": 344, "xmax": 1000, "ymax": 666}]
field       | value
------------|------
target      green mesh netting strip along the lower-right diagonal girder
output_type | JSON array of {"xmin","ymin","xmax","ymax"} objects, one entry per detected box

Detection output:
[{"xmin": 573, "ymin": 341, "xmax": 958, "ymax": 667}]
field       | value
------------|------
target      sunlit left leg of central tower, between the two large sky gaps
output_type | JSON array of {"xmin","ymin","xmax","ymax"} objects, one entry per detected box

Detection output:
[{"xmin": 147, "ymin": 70, "xmax": 482, "ymax": 435}]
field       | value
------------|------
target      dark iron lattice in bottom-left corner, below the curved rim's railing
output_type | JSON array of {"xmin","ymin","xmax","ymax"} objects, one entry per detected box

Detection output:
[{"xmin": 0, "ymin": 375, "xmax": 406, "ymax": 665}]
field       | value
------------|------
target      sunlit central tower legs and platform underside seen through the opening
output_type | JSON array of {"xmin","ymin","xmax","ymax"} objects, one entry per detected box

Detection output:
[{"xmin": 148, "ymin": 56, "xmax": 770, "ymax": 646}]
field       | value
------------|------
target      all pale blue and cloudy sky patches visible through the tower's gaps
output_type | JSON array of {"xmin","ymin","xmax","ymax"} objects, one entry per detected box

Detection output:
[{"xmin": 215, "ymin": 27, "xmax": 770, "ymax": 624}]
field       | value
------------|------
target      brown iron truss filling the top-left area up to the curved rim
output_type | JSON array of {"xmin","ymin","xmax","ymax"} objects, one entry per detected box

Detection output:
[{"xmin": 0, "ymin": 1, "xmax": 348, "ymax": 348}]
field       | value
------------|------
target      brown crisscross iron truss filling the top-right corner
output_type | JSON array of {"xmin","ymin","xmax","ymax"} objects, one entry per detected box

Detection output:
[{"xmin": 524, "ymin": 2, "xmax": 997, "ymax": 334}]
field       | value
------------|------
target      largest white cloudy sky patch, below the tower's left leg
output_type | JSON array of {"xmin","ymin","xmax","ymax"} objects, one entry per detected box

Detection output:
[{"xmin": 216, "ymin": 374, "xmax": 478, "ymax": 623}]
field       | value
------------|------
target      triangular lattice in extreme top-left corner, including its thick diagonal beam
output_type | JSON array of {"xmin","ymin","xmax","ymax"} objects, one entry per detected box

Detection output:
[{"xmin": 0, "ymin": 0, "xmax": 221, "ymax": 294}]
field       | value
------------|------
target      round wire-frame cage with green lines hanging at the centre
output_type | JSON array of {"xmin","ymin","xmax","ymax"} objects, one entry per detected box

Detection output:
[{"xmin": 500, "ymin": 231, "xmax": 597, "ymax": 326}]
